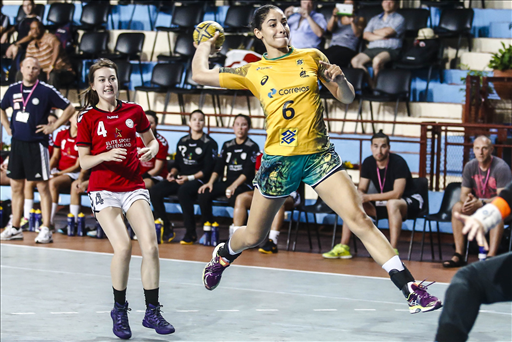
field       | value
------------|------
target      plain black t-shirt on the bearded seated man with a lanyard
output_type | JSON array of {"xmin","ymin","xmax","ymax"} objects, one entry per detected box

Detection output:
[{"xmin": 361, "ymin": 153, "xmax": 418, "ymax": 198}]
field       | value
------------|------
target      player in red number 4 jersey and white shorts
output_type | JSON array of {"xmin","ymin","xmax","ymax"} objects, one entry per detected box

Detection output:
[{"xmin": 77, "ymin": 59, "xmax": 174, "ymax": 339}]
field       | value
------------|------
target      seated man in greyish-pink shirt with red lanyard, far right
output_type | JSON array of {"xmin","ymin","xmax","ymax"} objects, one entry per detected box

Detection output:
[{"xmin": 443, "ymin": 135, "xmax": 512, "ymax": 268}]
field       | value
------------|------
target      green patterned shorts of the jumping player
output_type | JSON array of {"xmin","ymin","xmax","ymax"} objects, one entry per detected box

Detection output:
[{"xmin": 253, "ymin": 144, "xmax": 344, "ymax": 198}]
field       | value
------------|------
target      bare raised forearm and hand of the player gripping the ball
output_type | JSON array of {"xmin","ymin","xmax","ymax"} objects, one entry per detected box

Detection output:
[{"xmin": 192, "ymin": 32, "xmax": 220, "ymax": 87}]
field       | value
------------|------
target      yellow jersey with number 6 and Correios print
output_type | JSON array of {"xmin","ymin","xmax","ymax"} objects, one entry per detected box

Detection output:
[{"xmin": 220, "ymin": 48, "xmax": 330, "ymax": 156}]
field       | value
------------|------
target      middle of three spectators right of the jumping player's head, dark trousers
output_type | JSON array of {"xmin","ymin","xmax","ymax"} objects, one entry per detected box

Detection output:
[{"xmin": 325, "ymin": 0, "xmax": 366, "ymax": 67}]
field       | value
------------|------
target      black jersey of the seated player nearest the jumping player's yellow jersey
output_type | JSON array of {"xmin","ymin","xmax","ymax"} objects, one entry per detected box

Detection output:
[{"xmin": 214, "ymin": 138, "xmax": 260, "ymax": 184}]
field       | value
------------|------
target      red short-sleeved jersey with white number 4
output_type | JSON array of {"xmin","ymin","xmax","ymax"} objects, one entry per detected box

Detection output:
[{"xmin": 76, "ymin": 100, "xmax": 151, "ymax": 192}]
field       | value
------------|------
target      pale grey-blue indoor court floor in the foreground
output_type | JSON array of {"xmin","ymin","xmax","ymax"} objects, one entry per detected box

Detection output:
[{"xmin": 0, "ymin": 242, "xmax": 512, "ymax": 342}]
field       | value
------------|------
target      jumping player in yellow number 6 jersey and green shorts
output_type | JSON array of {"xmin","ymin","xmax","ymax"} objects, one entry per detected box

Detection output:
[{"xmin": 192, "ymin": 5, "xmax": 442, "ymax": 313}]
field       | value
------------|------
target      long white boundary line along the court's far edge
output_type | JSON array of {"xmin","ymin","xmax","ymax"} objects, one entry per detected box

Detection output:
[{"xmin": 2, "ymin": 244, "xmax": 450, "ymax": 286}]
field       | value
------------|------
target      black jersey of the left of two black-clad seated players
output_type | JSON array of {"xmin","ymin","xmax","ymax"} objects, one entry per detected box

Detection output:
[{"xmin": 174, "ymin": 134, "xmax": 219, "ymax": 181}]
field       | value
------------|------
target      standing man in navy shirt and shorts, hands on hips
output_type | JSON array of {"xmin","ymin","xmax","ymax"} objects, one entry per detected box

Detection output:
[{"xmin": 0, "ymin": 57, "xmax": 75, "ymax": 243}]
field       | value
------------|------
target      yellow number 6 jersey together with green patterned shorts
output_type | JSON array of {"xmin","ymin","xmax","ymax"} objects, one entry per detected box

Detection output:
[{"xmin": 219, "ymin": 47, "xmax": 341, "ymax": 197}]
